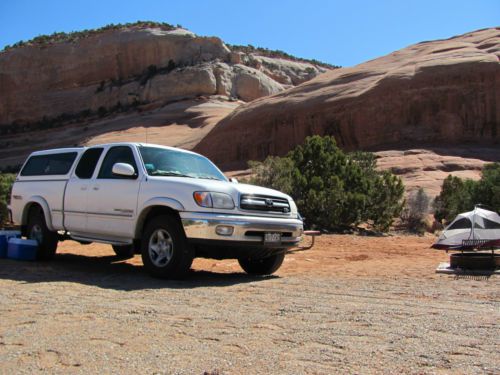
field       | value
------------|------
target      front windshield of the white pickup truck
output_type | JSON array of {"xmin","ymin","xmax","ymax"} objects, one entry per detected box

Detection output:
[{"xmin": 139, "ymin": 146, "xmax": 227, "ymax": 181}]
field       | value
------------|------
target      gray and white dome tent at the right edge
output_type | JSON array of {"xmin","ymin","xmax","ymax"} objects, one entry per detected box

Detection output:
[{"xmin": 432, "ymin": 207, "xmax": 500, "ymax": 250}]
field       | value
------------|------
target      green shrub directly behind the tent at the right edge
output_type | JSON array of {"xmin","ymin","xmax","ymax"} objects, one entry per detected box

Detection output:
[{"xmin": 434, "ymin": 163, "xmax": 500, "ymax": 222}]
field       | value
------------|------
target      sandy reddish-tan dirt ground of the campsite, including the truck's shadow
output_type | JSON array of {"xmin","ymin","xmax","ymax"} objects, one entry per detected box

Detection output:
[{"xmin": 0, "ymin": 235, "xmax": 500, "ymax": 374}]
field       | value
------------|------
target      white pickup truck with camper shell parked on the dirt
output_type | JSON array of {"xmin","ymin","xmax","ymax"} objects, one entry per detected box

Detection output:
[{"xmin": 9, "ymin": 143, "xmax": 303, "ymax": 278}]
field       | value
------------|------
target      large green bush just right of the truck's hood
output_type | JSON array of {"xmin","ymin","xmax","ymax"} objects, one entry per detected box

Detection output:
[{"xmin": 250, "ymin": 136, "xmax": 404, "ymax": 231}]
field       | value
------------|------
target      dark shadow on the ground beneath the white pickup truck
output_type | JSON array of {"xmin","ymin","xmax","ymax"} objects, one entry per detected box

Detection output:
[{"xmin": 0, "ymin": 254, "xmax": 278, "ymax": 291}]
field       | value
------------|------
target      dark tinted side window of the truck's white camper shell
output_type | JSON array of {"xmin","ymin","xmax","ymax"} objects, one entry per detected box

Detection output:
[{"xmin": 21, "ymin": 152, "xmax": 77, "ymax": 176}]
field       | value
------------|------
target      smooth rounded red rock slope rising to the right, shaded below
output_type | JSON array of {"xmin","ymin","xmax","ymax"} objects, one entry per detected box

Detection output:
[{"xmin": 195, "ymin": 28, "xmax": 500, "ymax": 169}]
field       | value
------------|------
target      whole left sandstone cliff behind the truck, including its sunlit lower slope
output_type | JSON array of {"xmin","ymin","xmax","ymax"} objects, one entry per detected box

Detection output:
[{"xmin": 0, "ymin": 22, "xmax": 329, "ymax": 169}]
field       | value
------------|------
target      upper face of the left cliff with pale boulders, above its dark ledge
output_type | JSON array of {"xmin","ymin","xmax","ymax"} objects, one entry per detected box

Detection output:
[{"xmin": 0, "ymin": 27, "xmax": 326, "ymax": 126}]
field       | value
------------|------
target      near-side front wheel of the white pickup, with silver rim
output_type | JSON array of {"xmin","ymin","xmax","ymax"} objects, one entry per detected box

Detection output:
[{"xmin": 141, "ymin": 215, "xmax": 194, "ymax": 279}]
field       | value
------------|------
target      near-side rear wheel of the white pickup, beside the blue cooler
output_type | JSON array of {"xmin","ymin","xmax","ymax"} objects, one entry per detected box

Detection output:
[{"xmin": 26, "ymin": 207, "xmax": 58, "ymax": 260}]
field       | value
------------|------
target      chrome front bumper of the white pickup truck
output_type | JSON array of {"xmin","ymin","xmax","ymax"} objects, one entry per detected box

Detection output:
[{"xmin": 180, "ymin": 212, "xmax": 304, "ymax": 247}]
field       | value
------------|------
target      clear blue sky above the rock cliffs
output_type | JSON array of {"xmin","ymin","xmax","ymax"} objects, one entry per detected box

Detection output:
[{"xmin": 0, "ymin": 0, "xmax": 500, "ymax": 66}]
